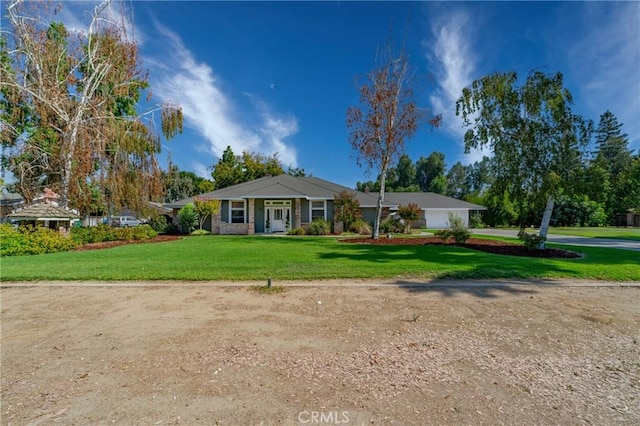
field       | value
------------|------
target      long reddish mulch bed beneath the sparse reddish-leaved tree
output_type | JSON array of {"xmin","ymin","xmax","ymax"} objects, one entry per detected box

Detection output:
[{"xmin": 340, "ymin": 237, "xmax": 581, "ymax": 259}]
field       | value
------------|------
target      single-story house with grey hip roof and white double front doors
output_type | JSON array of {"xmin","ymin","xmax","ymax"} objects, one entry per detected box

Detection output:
[{"xmin": 165, "ymin": 175, "xmax": 485, "ymax": 235}]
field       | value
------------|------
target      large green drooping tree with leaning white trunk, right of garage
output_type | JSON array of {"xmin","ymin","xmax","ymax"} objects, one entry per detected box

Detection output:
[{"xmin": 456, "ymin": 71, "xmax": 592, "ymax": 246}]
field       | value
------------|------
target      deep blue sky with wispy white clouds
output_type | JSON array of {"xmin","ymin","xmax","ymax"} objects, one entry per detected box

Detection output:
[{"xmin": 36, "ymin": 1, "xmax": 640, "ymax": 187}]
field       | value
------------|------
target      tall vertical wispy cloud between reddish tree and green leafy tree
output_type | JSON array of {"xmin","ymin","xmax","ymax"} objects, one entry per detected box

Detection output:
[{"xmin": 423, "ymin": 10, "xmax": 488, "ymax": 163}]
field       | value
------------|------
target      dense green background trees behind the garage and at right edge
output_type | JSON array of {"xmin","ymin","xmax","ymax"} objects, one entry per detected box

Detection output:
[{"xmin": 356, "ymin": 111, "xmax": 640, "ymax": 230}]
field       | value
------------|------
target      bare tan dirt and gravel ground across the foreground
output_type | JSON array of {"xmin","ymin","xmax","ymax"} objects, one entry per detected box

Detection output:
[{"xmin": 0, "ymin": 283, "xmax": 640, "ymax": 425}]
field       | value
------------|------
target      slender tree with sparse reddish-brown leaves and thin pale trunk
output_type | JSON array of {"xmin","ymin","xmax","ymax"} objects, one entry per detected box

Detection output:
[{"xmin": 347, "ymin": 47, "xmax": 441, "ymax": 239}]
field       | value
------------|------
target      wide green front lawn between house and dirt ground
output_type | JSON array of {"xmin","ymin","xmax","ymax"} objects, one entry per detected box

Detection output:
[{"xmin": 0, "ymin": 236, "xmax": 640, "ymax": 281}]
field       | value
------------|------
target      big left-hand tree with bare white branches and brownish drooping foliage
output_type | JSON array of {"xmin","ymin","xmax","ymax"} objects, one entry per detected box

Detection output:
[{"xmin": 0, "ymin": 0, "xmax": 182, "ymax": 213}]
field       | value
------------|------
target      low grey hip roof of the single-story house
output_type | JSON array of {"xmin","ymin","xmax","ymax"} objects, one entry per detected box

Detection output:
[{"xmin": 165, "ymin": 175, "xmax": 485, "ymax": 210}]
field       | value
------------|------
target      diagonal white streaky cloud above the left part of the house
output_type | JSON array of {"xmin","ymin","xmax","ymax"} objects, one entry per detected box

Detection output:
[{"xmin": 145, "ymin": 23, "xmax": 298, "ymax": 165}]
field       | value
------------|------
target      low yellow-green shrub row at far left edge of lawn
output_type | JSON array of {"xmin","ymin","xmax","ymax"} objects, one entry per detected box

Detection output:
[{"xmin": 0, "ymin": 224, "xmax": 77, "ymax": 256}]
